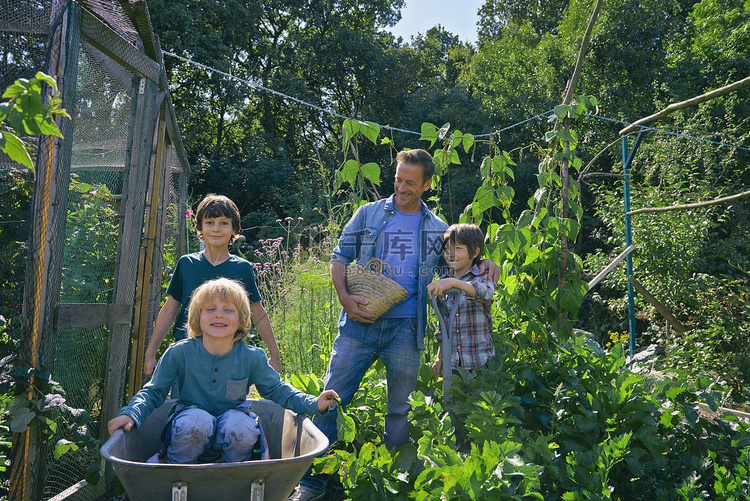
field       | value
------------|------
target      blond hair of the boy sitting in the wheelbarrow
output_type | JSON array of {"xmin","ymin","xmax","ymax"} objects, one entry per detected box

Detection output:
[{"xmin": 187, "ymin": 278, "xmax": 253, "ymax": 344}]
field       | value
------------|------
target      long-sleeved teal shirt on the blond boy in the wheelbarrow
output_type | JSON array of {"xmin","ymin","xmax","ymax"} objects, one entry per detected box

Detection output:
[{"xmin": 120, "ymin": 338, "xmax": 320, "ymax": 427}]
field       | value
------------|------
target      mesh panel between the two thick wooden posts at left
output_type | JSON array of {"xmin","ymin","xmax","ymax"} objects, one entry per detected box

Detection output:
[{"xmin": 44, "ymin": 41, "xmax": 131, "ymax": 497}]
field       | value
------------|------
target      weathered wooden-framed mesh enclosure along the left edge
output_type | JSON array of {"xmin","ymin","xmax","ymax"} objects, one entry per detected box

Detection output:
[{"xmin": 0, "ymin": 0, "xmax": 189, "ymax": 500}]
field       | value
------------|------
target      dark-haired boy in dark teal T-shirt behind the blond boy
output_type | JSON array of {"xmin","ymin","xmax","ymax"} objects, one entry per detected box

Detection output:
[{"xmin": 143, "ymin": 194, "xmax": 281, "ymax": 378}]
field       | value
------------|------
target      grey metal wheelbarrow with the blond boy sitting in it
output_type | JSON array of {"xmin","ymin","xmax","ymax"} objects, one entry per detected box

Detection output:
[{"xmin": 100, "ymin": 400, "xmax": 328, "ymax": 501}]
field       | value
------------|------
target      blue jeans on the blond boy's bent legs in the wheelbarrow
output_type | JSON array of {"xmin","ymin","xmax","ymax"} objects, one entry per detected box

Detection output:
[{"xmin": 167, "ymin": 406, "xmax": 260, "ymax": 463}]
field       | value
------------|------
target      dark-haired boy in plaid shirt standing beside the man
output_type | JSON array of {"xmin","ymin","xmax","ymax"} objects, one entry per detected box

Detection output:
[{"xmin": 427, "ymin": 224, "xmax": 495, "ymax": 376}]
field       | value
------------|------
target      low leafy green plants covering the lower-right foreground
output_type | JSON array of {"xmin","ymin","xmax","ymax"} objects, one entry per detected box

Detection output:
[{"xmin": 316, "ymin": 328, "xmax": 750, "ymax": 500}]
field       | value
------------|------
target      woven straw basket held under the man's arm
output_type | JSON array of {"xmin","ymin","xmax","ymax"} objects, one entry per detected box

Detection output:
[{"xmin": 346, "ymin": 258, "xmax": 408, "ymax": 320}]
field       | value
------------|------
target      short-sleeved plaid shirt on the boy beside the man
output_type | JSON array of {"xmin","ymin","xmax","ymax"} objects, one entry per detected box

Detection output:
[{"xmin": 437, "ymin": 265, "xmax": 495, "ymax": 370}]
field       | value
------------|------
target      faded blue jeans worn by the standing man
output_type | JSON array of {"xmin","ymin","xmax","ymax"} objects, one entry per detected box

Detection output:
[{"xmin": 300, "ymin": 318, "xmax": 421, "ymax": 491}]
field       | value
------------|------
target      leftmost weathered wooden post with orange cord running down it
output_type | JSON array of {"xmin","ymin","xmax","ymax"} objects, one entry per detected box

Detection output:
[{"xmin": 9, "ymin": 2, "xmax": 81, "ymax": 501}]
